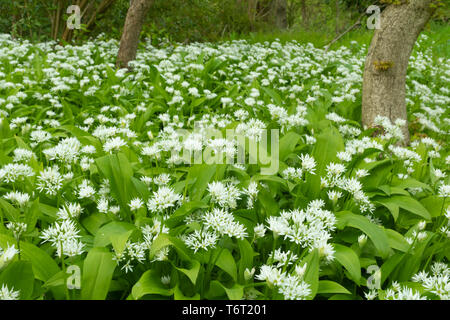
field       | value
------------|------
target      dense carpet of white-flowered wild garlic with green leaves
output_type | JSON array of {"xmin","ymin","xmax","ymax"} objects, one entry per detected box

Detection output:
[{"xmin": 0, "ymin": 35, "xmax": 450, "ymax": 299}]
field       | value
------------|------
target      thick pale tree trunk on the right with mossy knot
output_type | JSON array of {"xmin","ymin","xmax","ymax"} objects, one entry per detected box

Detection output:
[{"xmin": 362, "ymin": 0, "xmax": 434, "ymax": 144}]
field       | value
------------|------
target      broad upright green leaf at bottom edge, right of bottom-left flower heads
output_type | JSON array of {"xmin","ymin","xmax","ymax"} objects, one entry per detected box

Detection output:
[{"xmin": 81, "ymin": 248, "xmax": 116, "ymax": 300}]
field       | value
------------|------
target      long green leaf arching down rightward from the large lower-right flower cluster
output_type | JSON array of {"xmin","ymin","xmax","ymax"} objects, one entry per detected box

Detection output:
[{"xmin": 336, "ymin": 211, "xmax": 389, "ymax": 257}]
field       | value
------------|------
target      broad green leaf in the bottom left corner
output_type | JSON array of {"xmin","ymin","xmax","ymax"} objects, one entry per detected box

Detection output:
[{"xmin": 0, "ymin": 261, "xmax": 34, "ymax": 300}]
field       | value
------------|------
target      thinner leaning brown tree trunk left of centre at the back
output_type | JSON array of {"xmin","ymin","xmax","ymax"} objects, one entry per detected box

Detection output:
[{"xmin": 116, "ymin": 0, "xmax": 153, "ymax": 68}]
